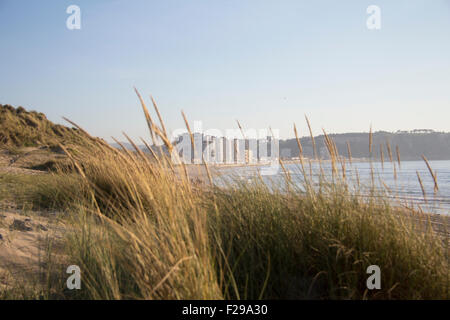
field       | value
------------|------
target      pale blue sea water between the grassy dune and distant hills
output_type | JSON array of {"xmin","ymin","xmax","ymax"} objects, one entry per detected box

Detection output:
[{"xmin": 214, "ymin": 160, "xmax": 450, "ymax": 214}]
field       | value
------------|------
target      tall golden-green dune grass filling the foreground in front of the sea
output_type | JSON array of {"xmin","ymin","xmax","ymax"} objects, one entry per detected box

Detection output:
[{"xmin": 37, "ymin": 90, "xmax": 450, "ymax": 299}]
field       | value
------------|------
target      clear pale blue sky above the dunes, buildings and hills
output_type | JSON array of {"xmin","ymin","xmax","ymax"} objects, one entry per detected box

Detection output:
[{"xmin": 0, "ymin": 0, "xmax": 450, "ymax": 141}]
